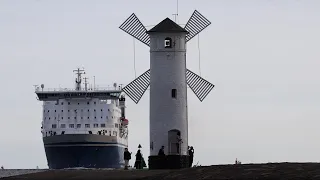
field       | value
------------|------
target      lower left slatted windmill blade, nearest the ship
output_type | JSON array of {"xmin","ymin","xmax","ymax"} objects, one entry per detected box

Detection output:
[{"xmin": 122, "ymin": 69, "xmax": 150, "ymax": 104}]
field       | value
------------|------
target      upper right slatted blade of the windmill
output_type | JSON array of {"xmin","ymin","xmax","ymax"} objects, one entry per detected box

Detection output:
[{"xmin": 184, "ymin": 10, "xmax": 211, "ymax": 42}]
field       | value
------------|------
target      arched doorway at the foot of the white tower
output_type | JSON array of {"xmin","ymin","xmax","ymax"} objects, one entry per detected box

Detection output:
[{"xmin": 168, "ymin": 129, "xmax": 181, "ymax": 155}]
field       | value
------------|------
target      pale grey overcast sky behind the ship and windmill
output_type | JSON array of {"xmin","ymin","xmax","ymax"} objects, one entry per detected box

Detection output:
[{"xmin": 0, "ymin": 0, "xmax": 320, "ymax": 168}]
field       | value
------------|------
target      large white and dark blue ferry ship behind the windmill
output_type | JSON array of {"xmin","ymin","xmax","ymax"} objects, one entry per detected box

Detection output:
[{"xmin": 35, "ymin": 68, "xmax": 128, "ymax": 169}]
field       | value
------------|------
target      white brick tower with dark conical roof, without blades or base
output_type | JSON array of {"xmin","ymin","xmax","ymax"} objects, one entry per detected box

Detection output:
[{"xmin": 147, "ymin": 18, "xmax": 188, "ymax": 156}]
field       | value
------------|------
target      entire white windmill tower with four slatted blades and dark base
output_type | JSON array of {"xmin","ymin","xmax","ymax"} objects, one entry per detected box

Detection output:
[{"xmin": 120, "ymin": 11, "xmax": 214, "ymax": 169}]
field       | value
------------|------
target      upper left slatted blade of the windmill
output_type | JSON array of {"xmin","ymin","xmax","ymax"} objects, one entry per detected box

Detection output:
[{"xmin": 119, "ymin": 13, "xmax": 150, "ymax": 46}]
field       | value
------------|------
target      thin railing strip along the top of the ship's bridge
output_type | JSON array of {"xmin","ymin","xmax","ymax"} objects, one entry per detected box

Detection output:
[{"xmin": 35, "ymin": 87, "xmax": 121, "ymax": 92}]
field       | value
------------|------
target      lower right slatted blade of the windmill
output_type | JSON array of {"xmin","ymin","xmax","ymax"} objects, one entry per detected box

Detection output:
[{"xmin": 186, "ymin": 69, "xmax": 214, "ymax": 102}]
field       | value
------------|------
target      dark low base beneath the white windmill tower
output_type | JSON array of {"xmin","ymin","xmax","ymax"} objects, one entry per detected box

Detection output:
[{"xmin": 149, "ymin": 155, "xmax": 189, "ymax": 169}]
